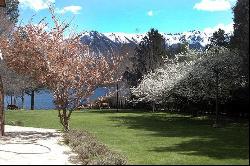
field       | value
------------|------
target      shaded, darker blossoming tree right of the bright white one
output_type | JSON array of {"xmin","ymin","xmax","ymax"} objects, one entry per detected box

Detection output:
[{"xmin": 175, "ymin": 47, "xmax": 246, "ymax": 102}]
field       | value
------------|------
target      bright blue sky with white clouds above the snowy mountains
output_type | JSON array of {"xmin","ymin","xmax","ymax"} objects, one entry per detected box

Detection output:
[{"xmin": 19, "ymin": 0, "xmax": 236, "ymax": 33}]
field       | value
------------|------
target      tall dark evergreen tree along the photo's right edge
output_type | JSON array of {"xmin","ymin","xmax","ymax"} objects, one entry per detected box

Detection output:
[{"xmin": 230, "ymin": 0, "xmax": 249, "ymax": 113}]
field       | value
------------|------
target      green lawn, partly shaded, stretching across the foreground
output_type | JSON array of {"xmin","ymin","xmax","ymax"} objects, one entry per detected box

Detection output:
[{"xmin": 6, "ymin": 110, "xmax": 249, "ymax": 165}]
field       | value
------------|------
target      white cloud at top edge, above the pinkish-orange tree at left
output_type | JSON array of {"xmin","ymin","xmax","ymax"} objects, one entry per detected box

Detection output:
[{"xmin": 19, "ymin": 0, "xmax": 55, "ymax": 11}]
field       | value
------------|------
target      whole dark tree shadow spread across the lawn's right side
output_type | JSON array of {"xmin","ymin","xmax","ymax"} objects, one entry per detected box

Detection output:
[{"xmin": 110, "ymin": 113, "xmax": 249, "ymax": 159}]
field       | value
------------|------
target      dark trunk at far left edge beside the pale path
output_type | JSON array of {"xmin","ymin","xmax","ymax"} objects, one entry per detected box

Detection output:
[{"xmin": 0, "ymin": 76, "xmax": 4, "ymax": 136}]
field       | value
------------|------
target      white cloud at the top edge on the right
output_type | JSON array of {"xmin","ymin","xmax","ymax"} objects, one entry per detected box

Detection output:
[{"xmin": 194, "ymin": 0, "xmax": 232, "ymax": 12}]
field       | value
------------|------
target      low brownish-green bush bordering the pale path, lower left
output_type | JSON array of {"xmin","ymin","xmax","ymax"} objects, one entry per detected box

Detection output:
[{"xmin": 64, "ymin": 130, "xmax": 127, "ymax": 165}]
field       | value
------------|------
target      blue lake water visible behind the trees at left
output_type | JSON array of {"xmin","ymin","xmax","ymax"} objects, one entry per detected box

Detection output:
[{"xmin": 4, "ymin": 88, "xmax": 108, "ymax": 110}]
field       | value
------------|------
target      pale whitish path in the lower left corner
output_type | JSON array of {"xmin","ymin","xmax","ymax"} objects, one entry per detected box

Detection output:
[{"xmin": 0, "ymin": 125, "xmax": 73, "ymax": 165}]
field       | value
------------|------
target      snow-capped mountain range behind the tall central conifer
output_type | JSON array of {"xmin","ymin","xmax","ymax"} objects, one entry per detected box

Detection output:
[{"xmin": 81, "ymin": 31, "xmax": 215, "ymax": 55}]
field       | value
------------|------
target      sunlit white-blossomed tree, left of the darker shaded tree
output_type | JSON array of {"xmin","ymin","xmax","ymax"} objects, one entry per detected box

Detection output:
[{"xmin": 132, "ymin": 50, "xmax": 199, "ymax": 111}]
